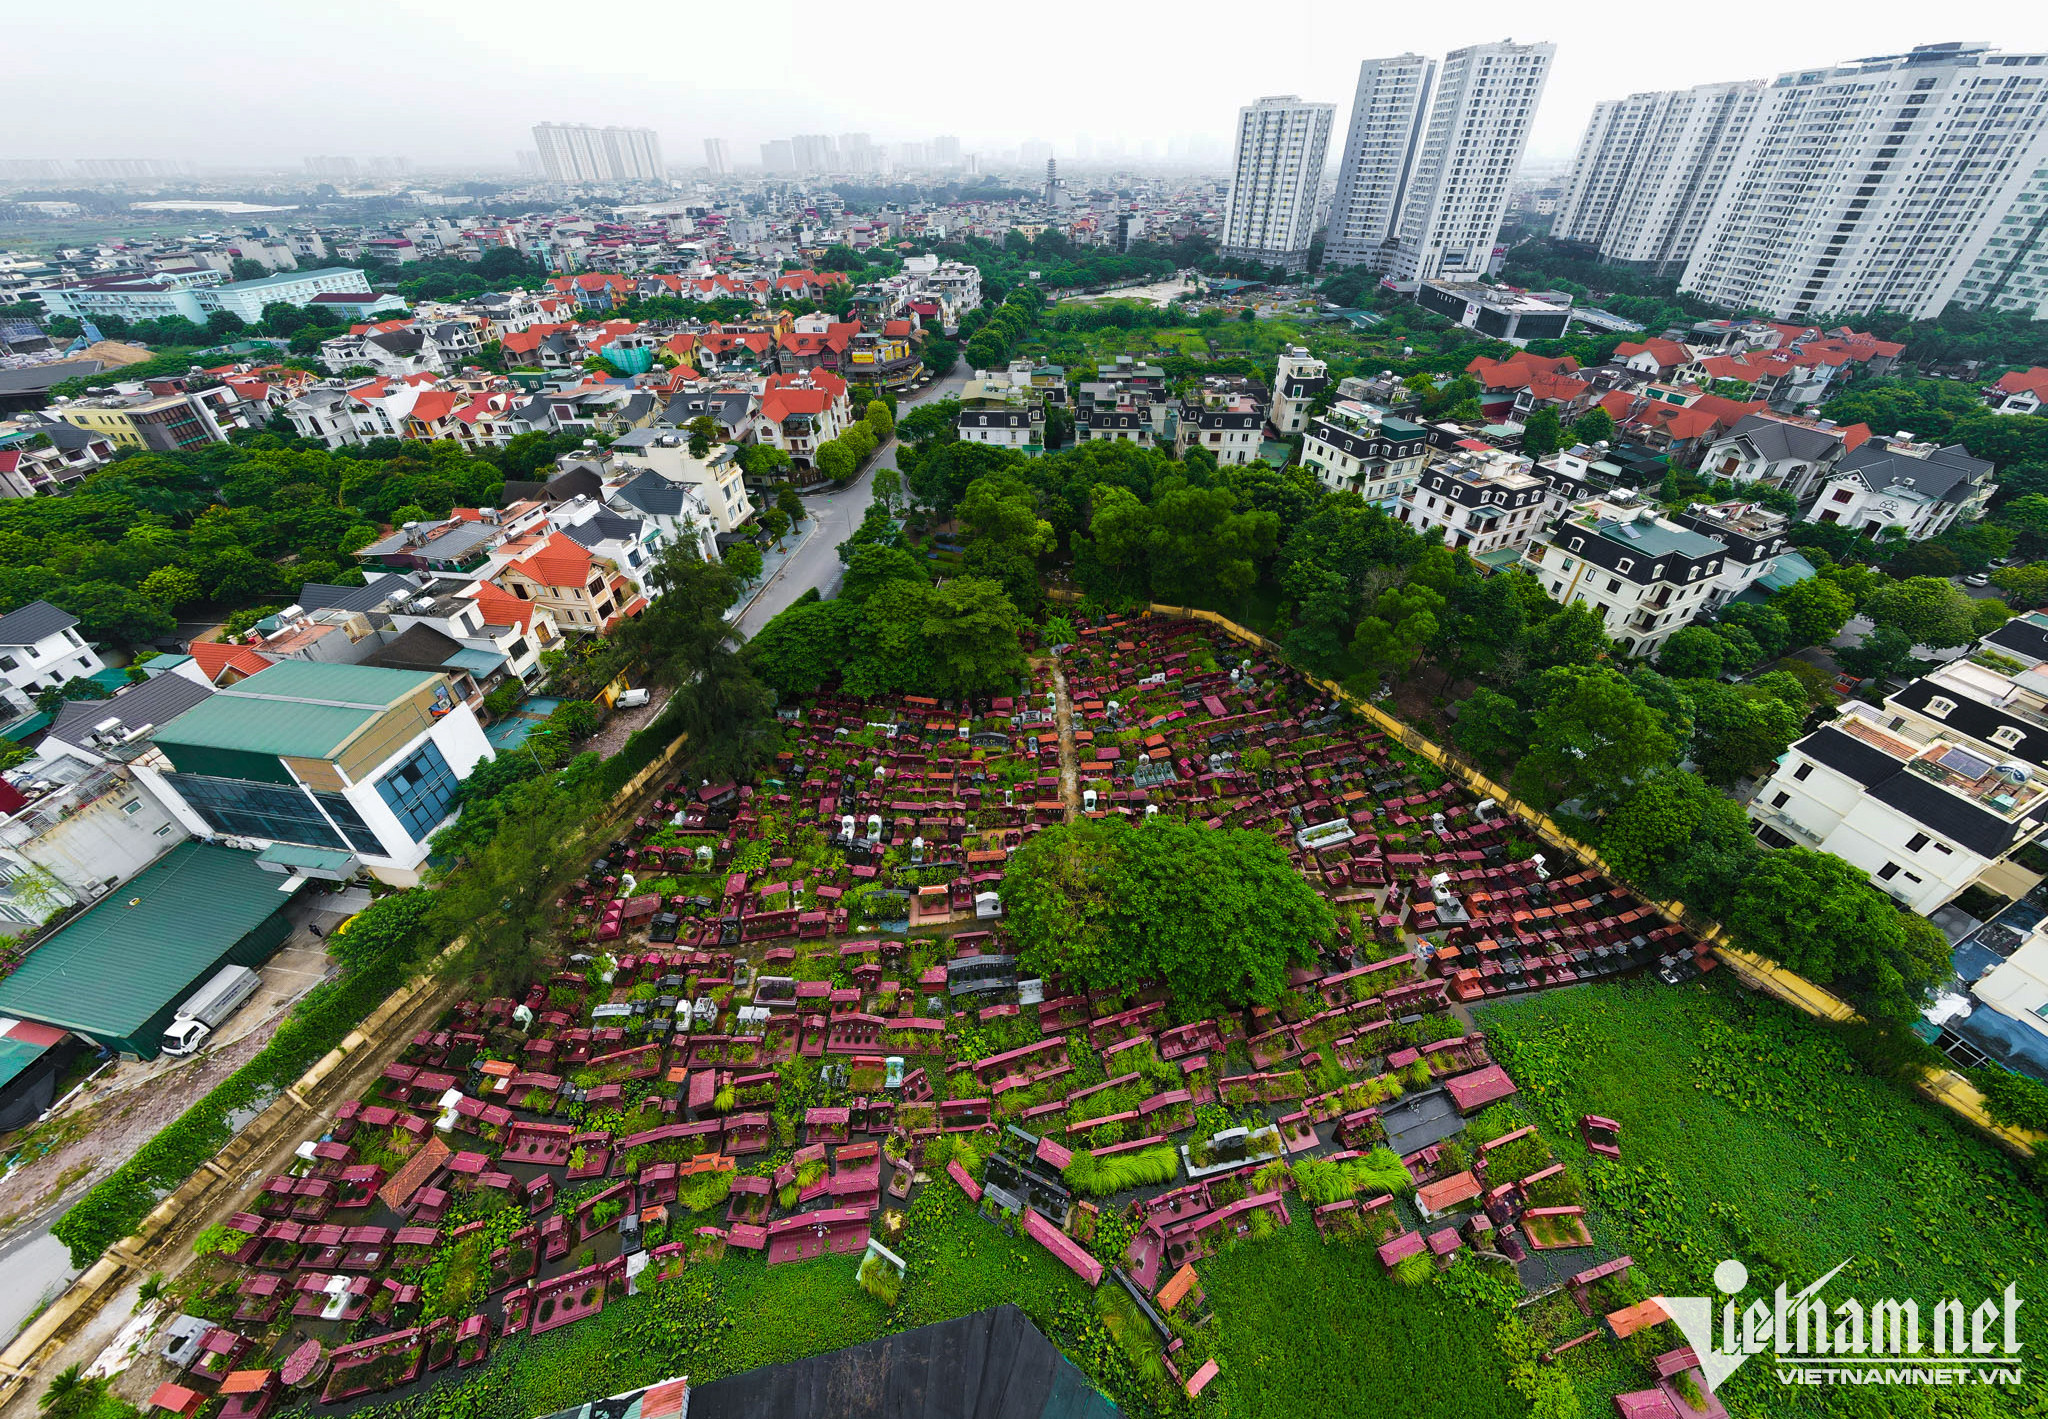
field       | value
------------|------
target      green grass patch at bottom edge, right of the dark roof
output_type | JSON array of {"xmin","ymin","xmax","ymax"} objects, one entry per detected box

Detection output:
[{"xmin": 1196, "ymin": 1206, "xmax": 1528, "ymax": 1419}]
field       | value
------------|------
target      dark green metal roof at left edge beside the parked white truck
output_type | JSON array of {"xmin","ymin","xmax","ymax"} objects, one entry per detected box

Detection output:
[{"xmin": 0, "ymin": 842, "xmax": 289, "ymax": 1038}]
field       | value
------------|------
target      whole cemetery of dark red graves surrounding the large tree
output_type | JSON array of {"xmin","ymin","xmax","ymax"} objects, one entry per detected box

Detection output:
[{"xmin": 136, "ymin": 618, "xmax": 1761, "ymax": 1415}]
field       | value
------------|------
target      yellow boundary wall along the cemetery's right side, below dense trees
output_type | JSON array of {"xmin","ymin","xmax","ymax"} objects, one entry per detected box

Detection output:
[{"xmin": 1073, "ymin": 590, "xmax": 2044, "ymax": 1155}]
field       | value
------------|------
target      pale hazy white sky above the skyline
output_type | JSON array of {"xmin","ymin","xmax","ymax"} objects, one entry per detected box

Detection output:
[{"xmin": 12, "ymin": 0, "xmax": 2048, "ymax": 168}]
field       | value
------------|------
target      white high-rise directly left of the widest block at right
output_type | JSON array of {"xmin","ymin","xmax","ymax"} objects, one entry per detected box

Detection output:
[{"xmin": 1550, "ymin": 80, "xmax": 1763, "ymax": 276}]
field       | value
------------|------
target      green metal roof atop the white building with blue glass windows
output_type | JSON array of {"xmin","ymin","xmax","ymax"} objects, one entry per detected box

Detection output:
[{"xmin": 154, "ymin": 659, "xmax": 436, "ymax": 762}]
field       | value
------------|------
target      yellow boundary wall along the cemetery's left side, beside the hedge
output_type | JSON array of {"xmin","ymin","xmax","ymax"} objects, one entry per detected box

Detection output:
[{"xmin": 0, "ymin": 724, "xmax": 686, "ymax": 1407}]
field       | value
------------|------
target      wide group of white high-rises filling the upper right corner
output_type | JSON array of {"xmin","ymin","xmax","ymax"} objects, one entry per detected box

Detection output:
[{"xmin": 1552, "ymin": 43, "xmax": 2048, "ymax": 319}]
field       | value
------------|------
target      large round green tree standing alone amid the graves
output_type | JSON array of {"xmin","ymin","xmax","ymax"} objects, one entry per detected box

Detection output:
[{"xmin": 999, "ymin": 817, "xmax": 1335, "ymax": 1009}]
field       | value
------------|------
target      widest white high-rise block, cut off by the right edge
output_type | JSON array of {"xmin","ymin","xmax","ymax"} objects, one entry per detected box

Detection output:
[{"xmin": 1679, "ymin": 43, "xmax": 2048, "ymax": 319}]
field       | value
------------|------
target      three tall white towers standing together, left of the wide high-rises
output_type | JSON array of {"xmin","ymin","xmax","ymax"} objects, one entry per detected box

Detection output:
[{"xmin": 1221, "ymin": 41, "xmax": 1556, "ymax": 281}]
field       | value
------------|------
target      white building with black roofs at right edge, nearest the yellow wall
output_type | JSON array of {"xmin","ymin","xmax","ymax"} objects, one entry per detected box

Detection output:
[{"xmin": 1749, "ymin": 659, "xmax": 2048, "ymax": 913}]
